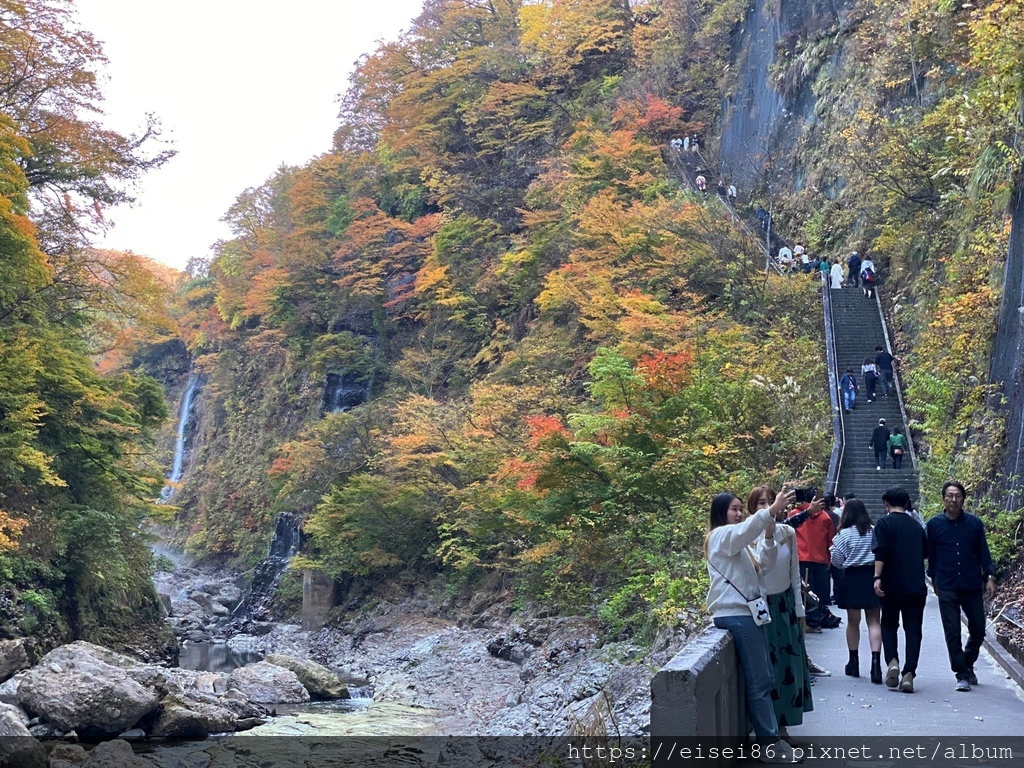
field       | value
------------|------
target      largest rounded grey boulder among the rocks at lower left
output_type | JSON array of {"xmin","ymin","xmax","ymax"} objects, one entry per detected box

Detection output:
[{"xmin": 17, "ymin": 641, "xmax": 159, "ymax": 734}]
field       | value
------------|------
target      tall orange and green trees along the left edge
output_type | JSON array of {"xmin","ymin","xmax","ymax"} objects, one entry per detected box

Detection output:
[{"xmin": 0, "ymin": 0, "xmax": 175, "ymax": 650}]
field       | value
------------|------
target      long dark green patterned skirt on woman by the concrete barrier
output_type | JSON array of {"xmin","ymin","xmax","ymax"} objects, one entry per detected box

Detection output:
[{"xmin": 765, "ymin": 588, "xmax": 814, "ymax": 726}]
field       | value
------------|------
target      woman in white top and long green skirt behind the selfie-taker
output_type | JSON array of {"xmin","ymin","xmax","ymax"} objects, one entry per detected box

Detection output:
[{"xmin": 746, "ymin": 485, "xmax": 814, "ymax": 738}]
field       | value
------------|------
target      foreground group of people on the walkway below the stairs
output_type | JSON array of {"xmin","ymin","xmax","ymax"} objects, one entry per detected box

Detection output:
[{"xmin": 705, "ymin": 480, "xmax": 995, "ymax": 763}]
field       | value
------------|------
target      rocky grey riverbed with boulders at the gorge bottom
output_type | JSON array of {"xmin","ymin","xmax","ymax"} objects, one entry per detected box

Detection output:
[{"xmin": 0, "ymin": 568, "xmax": 702, "ymax": 768}]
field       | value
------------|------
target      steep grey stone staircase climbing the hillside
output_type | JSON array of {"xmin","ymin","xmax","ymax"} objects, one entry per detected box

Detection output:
[{"xmin": 826, "ymin": 288, "xmax": 920, "ymax": 517}]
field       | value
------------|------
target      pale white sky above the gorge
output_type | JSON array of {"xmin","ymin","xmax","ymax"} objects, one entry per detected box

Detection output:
[{"xmin": 76, "ymin": 0, "xmax": 422, "ymax": 267}]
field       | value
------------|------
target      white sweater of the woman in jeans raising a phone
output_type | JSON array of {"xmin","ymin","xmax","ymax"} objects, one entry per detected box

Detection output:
[{"xmin": 708, "ymin": 509, "xmax": 778, "ymax": 617}]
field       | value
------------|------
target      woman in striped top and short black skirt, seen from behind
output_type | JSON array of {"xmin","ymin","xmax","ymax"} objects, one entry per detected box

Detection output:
[{"xmin": 831, "ymin": 499, "xmax": 882, "ymax": 684}]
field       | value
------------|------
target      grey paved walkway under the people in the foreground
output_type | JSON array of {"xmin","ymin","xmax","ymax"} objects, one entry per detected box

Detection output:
[{"xmin": 790, "ymin": 593, "xmax": 1024, "ymax": 737}]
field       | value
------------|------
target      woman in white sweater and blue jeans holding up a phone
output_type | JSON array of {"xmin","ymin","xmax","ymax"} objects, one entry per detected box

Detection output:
[{"xmin": 705, "ymin": 486, "xmax": 793, "ymax": 763}]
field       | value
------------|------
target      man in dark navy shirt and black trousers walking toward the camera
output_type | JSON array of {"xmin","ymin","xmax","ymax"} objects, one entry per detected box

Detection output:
[{"xmin": 928, "ymin": 480, "xmax": 995, "ymax": 692}]
